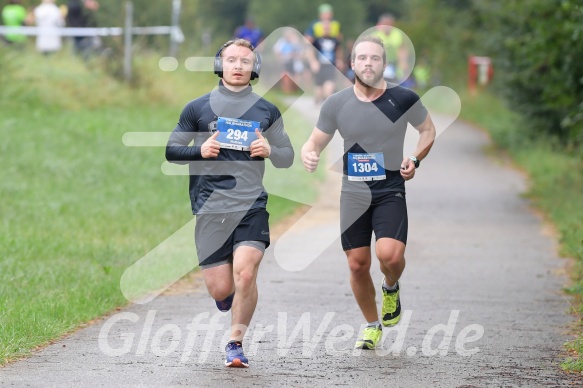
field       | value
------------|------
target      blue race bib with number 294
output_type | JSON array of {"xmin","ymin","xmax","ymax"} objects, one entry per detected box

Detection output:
[{"xmin": 217, "ymin": 117, "xmax": 261, "ymax": 151}]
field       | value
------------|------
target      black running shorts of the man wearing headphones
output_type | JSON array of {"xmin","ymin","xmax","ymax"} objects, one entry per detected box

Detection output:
[{"xmin": 194, "ymin": 209, "xmax": 270, "ymax": 269}]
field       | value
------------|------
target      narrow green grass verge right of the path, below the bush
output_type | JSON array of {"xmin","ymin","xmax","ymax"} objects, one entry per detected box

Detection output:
[{"xmin": 461, "ymin": 88, "xmax": 583, "ymax": 372}]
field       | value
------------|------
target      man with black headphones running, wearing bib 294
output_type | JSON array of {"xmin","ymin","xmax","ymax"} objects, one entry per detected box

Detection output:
[{"xmin": 166, "ymin": 39, "xmax": 294, "ymax": 367}]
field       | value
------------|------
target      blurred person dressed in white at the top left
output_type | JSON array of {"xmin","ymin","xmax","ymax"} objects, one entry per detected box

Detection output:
[{"xmin": 34, "ymin": 0, "xmax": 65, "ymax": 55}]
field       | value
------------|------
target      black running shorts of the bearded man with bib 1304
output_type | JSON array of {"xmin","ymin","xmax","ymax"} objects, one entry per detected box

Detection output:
[{"xmin": 340, "ymin": 192, "xmax": 408, "ymax": 251}]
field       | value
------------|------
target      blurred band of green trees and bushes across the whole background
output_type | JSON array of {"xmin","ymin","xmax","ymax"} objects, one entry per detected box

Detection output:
[{"xmin": 13, "ymin": 0, "xmax": 583, "ymax": 146}]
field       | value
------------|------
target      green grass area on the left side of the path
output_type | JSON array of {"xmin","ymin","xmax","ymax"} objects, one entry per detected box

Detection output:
[{"xmin": 0, "ymin": 47, "xmax": 316, "ymax": 365}]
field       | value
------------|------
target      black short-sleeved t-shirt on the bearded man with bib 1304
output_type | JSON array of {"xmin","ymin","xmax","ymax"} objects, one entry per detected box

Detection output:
[{"xmin": 316, "ymin": 84, "xmax": 427, "ymax": 193}]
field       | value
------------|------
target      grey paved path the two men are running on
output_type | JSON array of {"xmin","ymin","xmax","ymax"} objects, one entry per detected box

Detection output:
[{"xmin": 0, "ymin": 94, "xmax": 582, "ymax": 387}]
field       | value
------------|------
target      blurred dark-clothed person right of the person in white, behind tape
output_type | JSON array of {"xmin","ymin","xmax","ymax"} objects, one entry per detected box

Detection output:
[{"xmin": 65, "ymin": 0, "xmax": 99, "ymax": 59}]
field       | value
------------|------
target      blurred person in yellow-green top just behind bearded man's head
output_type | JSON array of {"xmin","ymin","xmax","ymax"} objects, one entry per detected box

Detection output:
[{"xmin": 371, "ymin": 13, "xmax": 409, "ymax": 83}]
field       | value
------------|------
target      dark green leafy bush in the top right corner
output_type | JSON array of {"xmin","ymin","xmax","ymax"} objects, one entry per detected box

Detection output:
[{"xmin": 482, "ymin": 0, "xmax": 583, "ymax": 146}]
